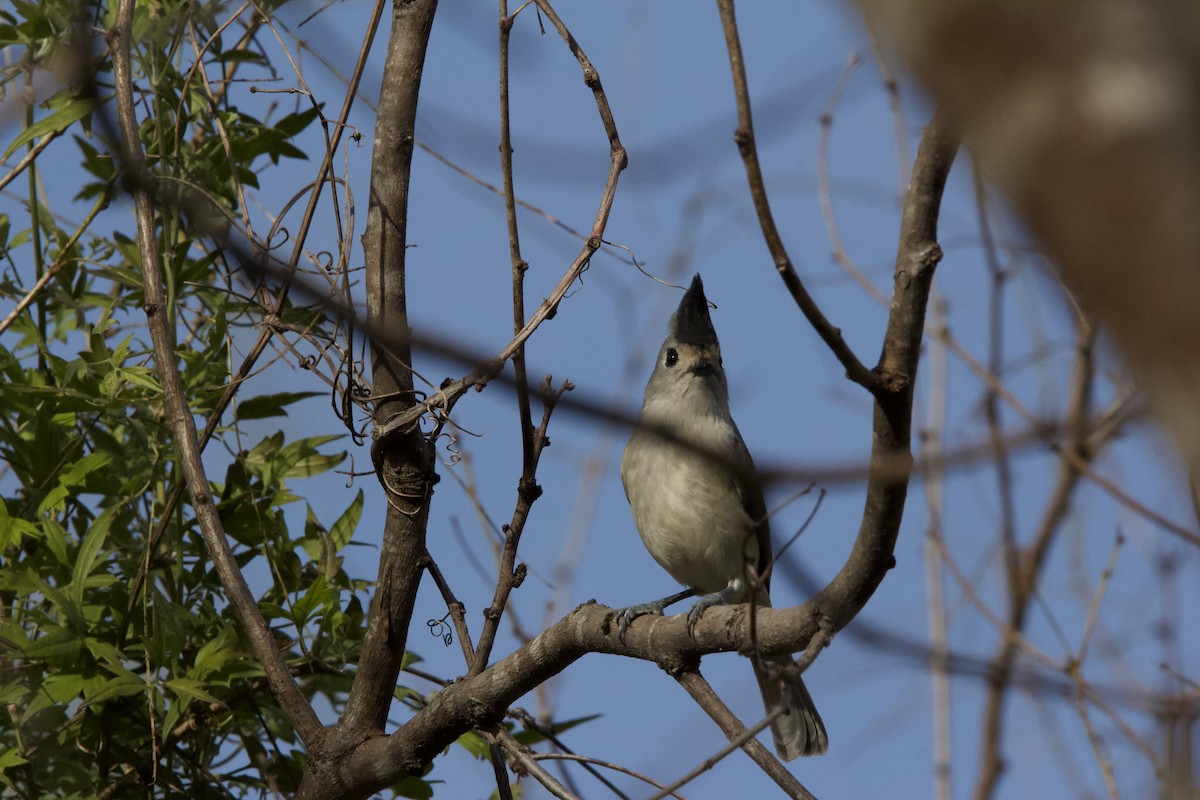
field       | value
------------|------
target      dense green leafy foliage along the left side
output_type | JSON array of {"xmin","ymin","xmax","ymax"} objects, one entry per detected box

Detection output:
[{"xmin": 0, "ymin": 0, "xmax": 374, "ymax": 799}]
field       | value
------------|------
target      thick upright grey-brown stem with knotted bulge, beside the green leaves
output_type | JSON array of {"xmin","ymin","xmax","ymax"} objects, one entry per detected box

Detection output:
[{"xmin": 338, "ymin": 0, "xmax": 437, "ymax": 746}]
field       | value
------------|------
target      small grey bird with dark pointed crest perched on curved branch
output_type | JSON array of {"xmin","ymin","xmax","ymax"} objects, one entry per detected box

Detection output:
[{"xmin": 618, "ymin": 275, "xmax": 829, "ymax": 760}]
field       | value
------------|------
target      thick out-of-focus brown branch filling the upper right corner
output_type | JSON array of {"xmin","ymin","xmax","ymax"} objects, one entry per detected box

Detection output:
[{"xmin": 858, "ymin": 0, "xmax": 1200, "ymax": 543}]
